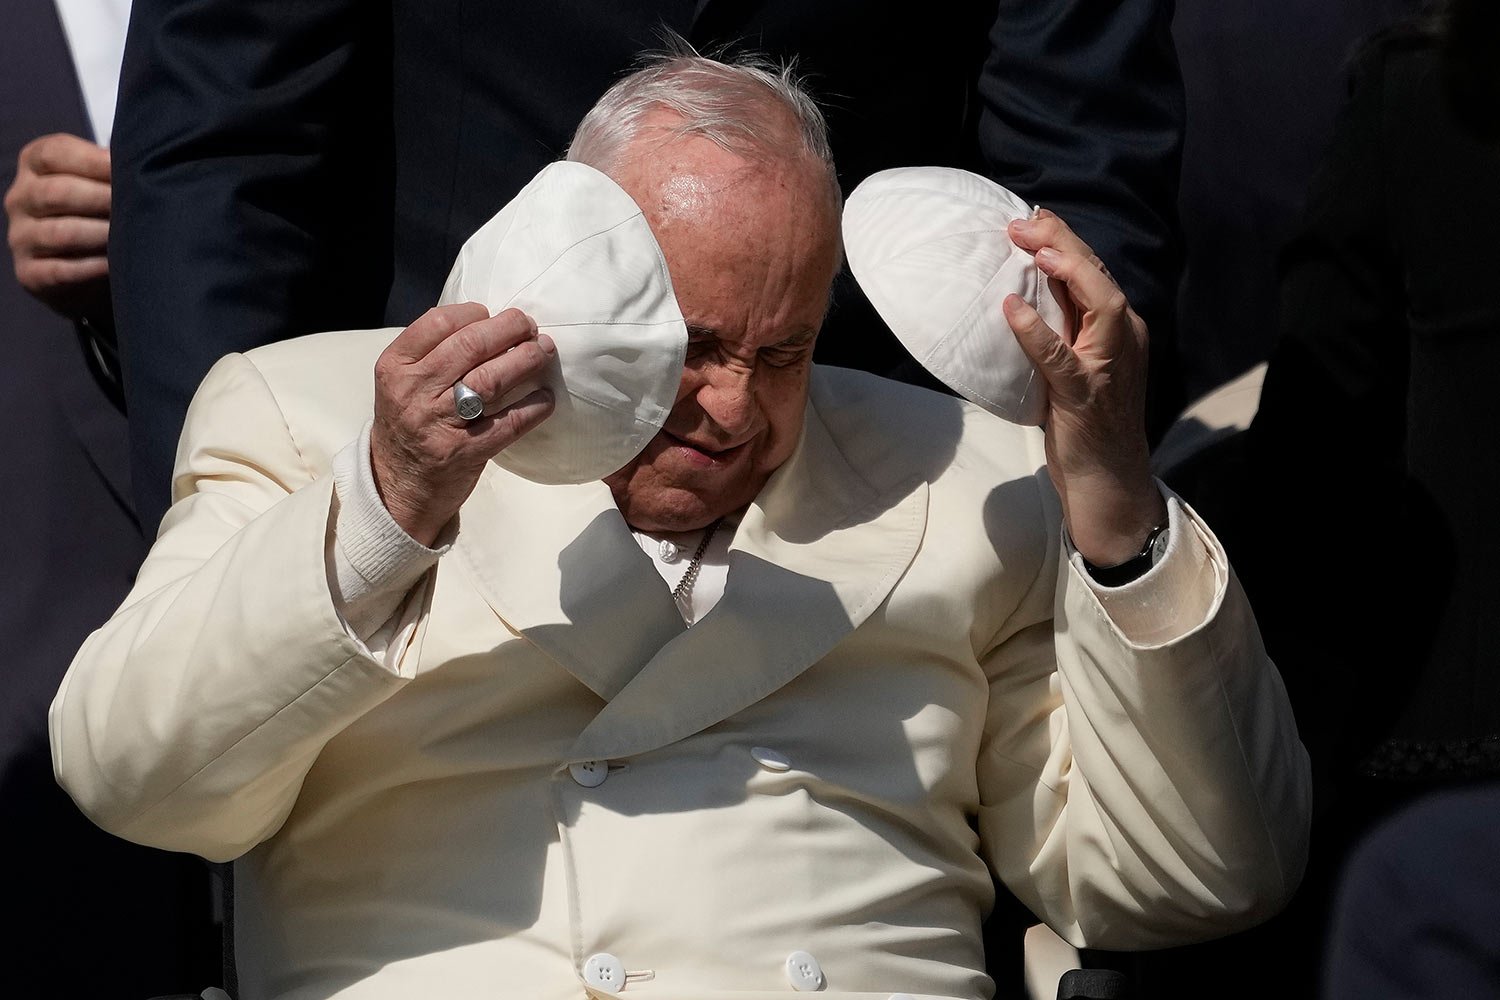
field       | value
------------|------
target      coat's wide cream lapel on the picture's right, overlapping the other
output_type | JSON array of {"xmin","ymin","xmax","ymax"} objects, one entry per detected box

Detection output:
[{"xmin": 570, "ymin": 389, "xmax": 927, "ymax": 760}]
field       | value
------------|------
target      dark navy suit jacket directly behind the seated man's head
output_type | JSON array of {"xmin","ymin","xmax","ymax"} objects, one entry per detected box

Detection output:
[{"xmin": 111, "ymin": 0, "xmax": 1182, "ymax": 523}]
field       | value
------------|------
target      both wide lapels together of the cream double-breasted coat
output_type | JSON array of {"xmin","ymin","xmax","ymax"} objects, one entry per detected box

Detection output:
[{"xmin": 453, "ymin": 374, "xmax": 927, "ymax": 760}]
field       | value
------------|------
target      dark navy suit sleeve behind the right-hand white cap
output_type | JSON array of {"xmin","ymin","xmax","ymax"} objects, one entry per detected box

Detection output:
[{"xmin": 978, "ymin": 0, "xmax": 1187, "ymax": 432}]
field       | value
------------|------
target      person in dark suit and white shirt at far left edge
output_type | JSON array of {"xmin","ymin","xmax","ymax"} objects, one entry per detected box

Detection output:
[{"xmin": 0, "ymin": 0, "xmax": 219, "ymax": 1000}]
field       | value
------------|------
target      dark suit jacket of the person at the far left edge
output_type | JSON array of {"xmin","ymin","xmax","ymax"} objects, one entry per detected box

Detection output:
[{"xmin": 0, "ymin": 0, "xmax": 218, "ymax": 1000}]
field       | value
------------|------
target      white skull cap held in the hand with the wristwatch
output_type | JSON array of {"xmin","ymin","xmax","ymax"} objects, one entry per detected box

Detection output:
[{"xmin": 843, "ymin": 166, "xmax": 1070, "ymax": 424}]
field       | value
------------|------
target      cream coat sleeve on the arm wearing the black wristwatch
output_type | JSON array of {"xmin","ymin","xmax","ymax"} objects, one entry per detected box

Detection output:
[{"xmin": 978, "ymin": 473, "xmax": 1311, "ymax": 951}]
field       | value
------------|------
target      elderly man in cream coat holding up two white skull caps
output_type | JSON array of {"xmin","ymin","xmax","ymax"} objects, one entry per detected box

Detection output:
[{"xmin": 53, "ymin": 57, "xmax": 1308, "ymax": 1000}]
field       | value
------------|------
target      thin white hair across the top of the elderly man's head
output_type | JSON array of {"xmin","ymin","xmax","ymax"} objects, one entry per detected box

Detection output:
[{"xmin": 567, "ymin": 39, "xmax": 834, "ymax": 180}]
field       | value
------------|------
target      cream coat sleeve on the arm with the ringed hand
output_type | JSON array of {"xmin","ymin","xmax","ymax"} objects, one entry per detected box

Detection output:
[{"xmin": 50, "ymin": 355, "xmax": 431, "ymax": 861}]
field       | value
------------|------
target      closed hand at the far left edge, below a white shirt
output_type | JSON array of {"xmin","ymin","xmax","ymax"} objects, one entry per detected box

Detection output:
[{"xmin": 5, "ymin": 132, "xmax": 110, "ymax": 319}]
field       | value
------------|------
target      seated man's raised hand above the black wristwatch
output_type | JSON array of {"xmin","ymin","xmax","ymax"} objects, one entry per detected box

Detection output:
[{"xmin": 1004, "ymin": 210, "xmax": 1167, "ymax": 565}]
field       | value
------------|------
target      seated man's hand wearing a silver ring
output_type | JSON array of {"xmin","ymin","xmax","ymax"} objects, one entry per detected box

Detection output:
[{"xmin": 371, "ymin": 303, "xmax": 557, "ymax": 546}]
